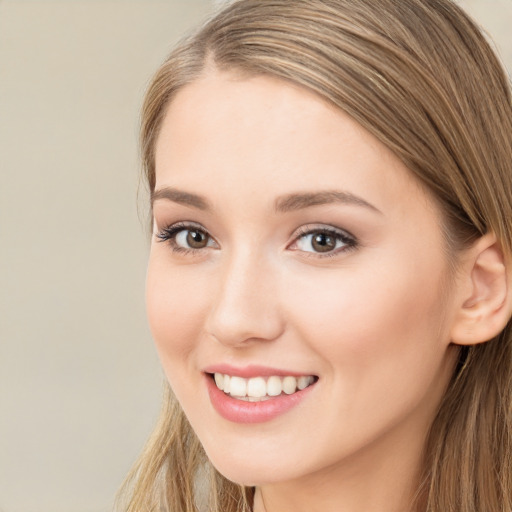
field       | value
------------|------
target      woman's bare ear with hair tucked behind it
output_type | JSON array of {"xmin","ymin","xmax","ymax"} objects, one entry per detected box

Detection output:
[{"xmin": 451, "ymin": 233, "xmax": 512, "ymax": 345}]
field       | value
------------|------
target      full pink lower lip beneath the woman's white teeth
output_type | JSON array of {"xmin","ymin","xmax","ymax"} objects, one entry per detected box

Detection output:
[{"xmin": 205, "ymin": 369, "xmax": 315, "ymax": 423}]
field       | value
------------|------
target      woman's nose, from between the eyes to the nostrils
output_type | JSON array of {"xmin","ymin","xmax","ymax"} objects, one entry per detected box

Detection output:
[{"xmin": 206, "ymin": 250, "xmax": 284, "ymax": 347}]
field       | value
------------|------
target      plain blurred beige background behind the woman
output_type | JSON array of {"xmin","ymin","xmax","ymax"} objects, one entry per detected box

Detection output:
[{"xmin": 0, "ymin": 0, "xmax": 512, "ymax": 512}]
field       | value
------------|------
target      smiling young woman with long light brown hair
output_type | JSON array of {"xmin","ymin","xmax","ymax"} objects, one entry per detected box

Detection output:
[{"xmin": 117, "ymin": 0, "xmax": 512, "ymax": 512}]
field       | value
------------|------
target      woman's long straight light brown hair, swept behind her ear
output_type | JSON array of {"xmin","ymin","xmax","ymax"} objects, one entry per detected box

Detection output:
[{"xmin": 118, "ymin": 0, "xmax": 512, "ymax": 512}]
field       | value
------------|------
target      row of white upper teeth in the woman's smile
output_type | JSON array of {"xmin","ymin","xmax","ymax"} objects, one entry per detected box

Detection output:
[{"xmin": 214, "ymin": 373, "xmax": 315, "ymax": 401}]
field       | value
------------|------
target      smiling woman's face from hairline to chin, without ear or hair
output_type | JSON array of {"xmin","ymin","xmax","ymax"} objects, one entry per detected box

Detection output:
[{"xmin": 147, "ymin": 73, "xmax": 456, "ymax": 485}]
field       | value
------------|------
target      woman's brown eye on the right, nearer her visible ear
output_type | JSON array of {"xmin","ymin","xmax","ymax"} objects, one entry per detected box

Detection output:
[{"xmin": 289, "ymin": 227, "xmax": 357, "ymax": 256}]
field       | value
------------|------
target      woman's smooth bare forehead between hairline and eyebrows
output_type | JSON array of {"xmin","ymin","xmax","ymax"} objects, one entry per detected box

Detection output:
[{"xmin": 155, "ymin": 72, "xmax": 431, "ymax": 223}]
